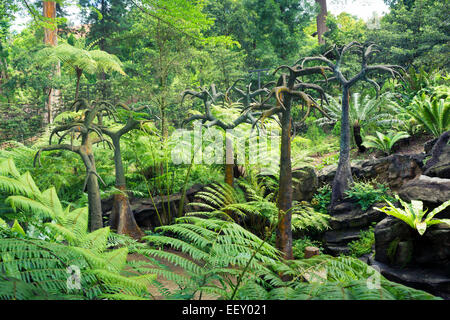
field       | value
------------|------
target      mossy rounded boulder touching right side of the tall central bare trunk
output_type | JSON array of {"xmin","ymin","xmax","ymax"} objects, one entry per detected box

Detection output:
[{"xmin": 292, "ymin": 166, "xmax": 319, "ymax": 201}]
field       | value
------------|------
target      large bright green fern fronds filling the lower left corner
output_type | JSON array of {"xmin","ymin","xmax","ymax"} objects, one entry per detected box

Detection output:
[{"xmin": 0, "ymin": 163, "xmax": 156, "ymax": 299}]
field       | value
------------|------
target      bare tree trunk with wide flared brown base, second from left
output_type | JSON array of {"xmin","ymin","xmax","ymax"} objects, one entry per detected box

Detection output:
[{"xmin": 110, "ymin": 136, "xmax": 144, "ymax": 240}]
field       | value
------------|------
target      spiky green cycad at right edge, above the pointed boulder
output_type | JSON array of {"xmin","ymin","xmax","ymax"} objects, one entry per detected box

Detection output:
[{"xmin": 405, "ymin": 92, "xmax": 450, "ymax": 137}]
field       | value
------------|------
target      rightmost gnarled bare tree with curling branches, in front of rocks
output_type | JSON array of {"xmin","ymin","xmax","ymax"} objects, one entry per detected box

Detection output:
[{"xmin": 298, "ymin": 41, "xmax": 403, "ymax": 211}]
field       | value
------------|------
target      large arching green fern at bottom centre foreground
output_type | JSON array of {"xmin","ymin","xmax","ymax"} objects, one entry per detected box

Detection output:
[{"xmin": 144, "ymin": 216, "xmax": 279, "ymax": 298}]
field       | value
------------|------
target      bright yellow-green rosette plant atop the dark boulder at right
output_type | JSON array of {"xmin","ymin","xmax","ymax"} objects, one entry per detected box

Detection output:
[{"xmin": 375, "ymin": 195, "xmax": 450, "ymax": 235}]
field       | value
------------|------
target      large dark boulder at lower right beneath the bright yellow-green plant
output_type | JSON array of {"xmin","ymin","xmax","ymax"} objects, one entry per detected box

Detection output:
[{"xmin": 369, "ymin": 217, "xmax": 450, "ymax": 299}]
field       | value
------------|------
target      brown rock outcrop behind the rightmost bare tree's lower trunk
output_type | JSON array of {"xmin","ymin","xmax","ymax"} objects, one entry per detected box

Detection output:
[{"xmin": 318, "ymin": 154, "xmax": 425, "ymax": 190}]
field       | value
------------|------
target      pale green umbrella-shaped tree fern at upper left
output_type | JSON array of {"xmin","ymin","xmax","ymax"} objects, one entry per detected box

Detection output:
[{"xmin": 37, "ymin": 39, "xmax": 125, "ymax": 100}]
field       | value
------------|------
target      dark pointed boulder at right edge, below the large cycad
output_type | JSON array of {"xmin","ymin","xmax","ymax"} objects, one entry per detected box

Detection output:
[{"xmin": 423, "ymin": 131, "xmax": 450, "ymax": 179}]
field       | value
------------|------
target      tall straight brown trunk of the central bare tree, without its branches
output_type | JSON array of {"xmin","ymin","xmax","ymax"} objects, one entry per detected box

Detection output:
[{"xmin": 276, "ymin": 102, "xmax": 293, "ymax": 259}]
